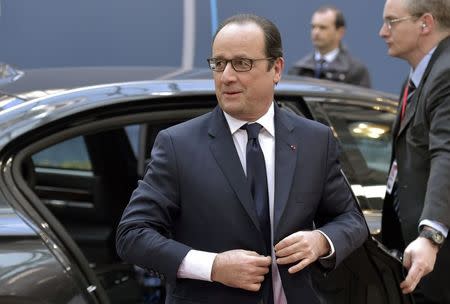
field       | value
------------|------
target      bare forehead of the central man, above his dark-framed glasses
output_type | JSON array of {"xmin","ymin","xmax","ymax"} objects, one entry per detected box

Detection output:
[{"xmin": 212, "ymin": 23, "xmax": 265, "ymax": 56}]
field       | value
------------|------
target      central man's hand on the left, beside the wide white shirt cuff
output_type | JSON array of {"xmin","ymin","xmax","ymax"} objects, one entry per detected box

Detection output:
[{"xmin": 211, "ymin": 249, "xmax": 272, "ymax": 291}]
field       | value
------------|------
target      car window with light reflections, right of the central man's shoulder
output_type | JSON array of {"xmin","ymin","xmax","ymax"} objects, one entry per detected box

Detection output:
[{"xmin": 312, "ymin": 101, "xmax": 395, "ymax": 210}]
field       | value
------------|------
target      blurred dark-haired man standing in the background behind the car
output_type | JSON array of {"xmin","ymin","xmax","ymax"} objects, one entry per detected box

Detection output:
[{"xmin": 289, "ymin": 5, "xmax": 370, "ymax": 87}]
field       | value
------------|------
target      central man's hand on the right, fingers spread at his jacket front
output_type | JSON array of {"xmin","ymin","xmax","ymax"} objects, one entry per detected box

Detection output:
[{"xmin": 275, "ymin": 231, "xmax": 330, "ymax": 273}]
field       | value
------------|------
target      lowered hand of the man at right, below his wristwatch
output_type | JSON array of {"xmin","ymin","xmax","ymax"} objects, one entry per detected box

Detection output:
[{"xmin": 400, "ymin": 237, "xmax": 439, "ymax": 294}]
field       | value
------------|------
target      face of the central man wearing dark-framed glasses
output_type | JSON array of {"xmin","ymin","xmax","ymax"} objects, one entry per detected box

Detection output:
[{"xmin": 212, "ymin": 23, "xmax": 284, "ymax": 121}]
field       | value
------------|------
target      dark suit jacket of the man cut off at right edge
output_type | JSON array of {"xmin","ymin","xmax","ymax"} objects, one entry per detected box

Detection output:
[{"xmin": 382, "ymin": 38, "xmax": 450, "ymax": 303}]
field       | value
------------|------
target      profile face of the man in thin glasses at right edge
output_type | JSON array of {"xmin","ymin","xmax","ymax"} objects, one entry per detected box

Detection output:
[{"xmin": 379, "ymin": 0, "xmax": 422, "ymax": 63}]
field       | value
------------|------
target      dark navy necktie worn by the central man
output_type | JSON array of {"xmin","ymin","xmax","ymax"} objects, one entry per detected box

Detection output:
[{"xmin": 241, "ymin": 123, "xmax": 273, "ymax": 304}]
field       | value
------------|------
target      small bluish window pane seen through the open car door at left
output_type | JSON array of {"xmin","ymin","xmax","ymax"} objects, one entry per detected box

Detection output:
[{"xmin": 32, "ymin": 136, "xmax": 92, "ymax": 171}]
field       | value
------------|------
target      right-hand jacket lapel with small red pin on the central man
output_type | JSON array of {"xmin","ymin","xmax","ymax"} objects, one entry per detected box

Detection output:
[{"xmin": 273, "ymin": 106, "xmax": 299, "ymax": 239}]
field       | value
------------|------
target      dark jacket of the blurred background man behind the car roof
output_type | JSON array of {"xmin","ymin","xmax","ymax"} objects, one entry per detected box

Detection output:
[{"xmin": 288, "ymin": 48, "xmax": 370, "ymax": 88}]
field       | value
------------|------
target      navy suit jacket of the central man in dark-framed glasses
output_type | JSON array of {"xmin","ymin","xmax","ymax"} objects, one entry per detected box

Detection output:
[{"xmin": 117, "ymin": 105, "xmax": 367, "ymax": 304}]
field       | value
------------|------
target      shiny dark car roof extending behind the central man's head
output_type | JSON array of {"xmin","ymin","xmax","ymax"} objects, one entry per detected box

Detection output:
[{"xmin": 0, "ymin": 67, "xmax": 396, "ymax": 148}]
